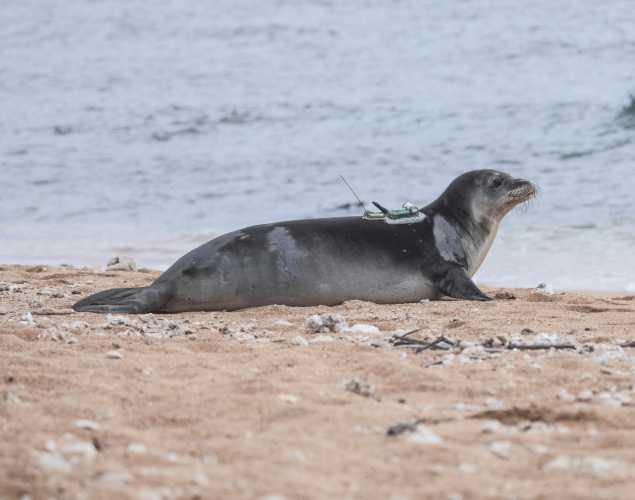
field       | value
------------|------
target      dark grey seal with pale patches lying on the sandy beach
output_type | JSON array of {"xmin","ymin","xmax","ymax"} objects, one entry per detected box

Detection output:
[{"xmin": 73, "ymin": 170, "xmax": 536, "ymax": 313}]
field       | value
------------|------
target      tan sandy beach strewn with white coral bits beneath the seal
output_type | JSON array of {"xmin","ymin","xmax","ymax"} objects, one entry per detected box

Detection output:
[{"xmin": 0, "ymin": 266, "xmax": 635, "ymax": 500}]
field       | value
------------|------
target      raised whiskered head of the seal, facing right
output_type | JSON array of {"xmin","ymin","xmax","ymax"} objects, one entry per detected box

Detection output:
[{"xmin": 431, "ymin": 170, "xmax": 536, "ymax": 224}]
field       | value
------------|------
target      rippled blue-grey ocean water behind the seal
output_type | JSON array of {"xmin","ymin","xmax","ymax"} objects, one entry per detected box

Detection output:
[{"xmin": 0, "ymin": 0, "xmax": 635, "ymax": 292}]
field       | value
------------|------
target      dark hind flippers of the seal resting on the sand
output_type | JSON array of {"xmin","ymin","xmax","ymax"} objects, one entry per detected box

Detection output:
[{"xmin": 73, "ymin": 286, "xmax": 170, "ymax": 314}]
